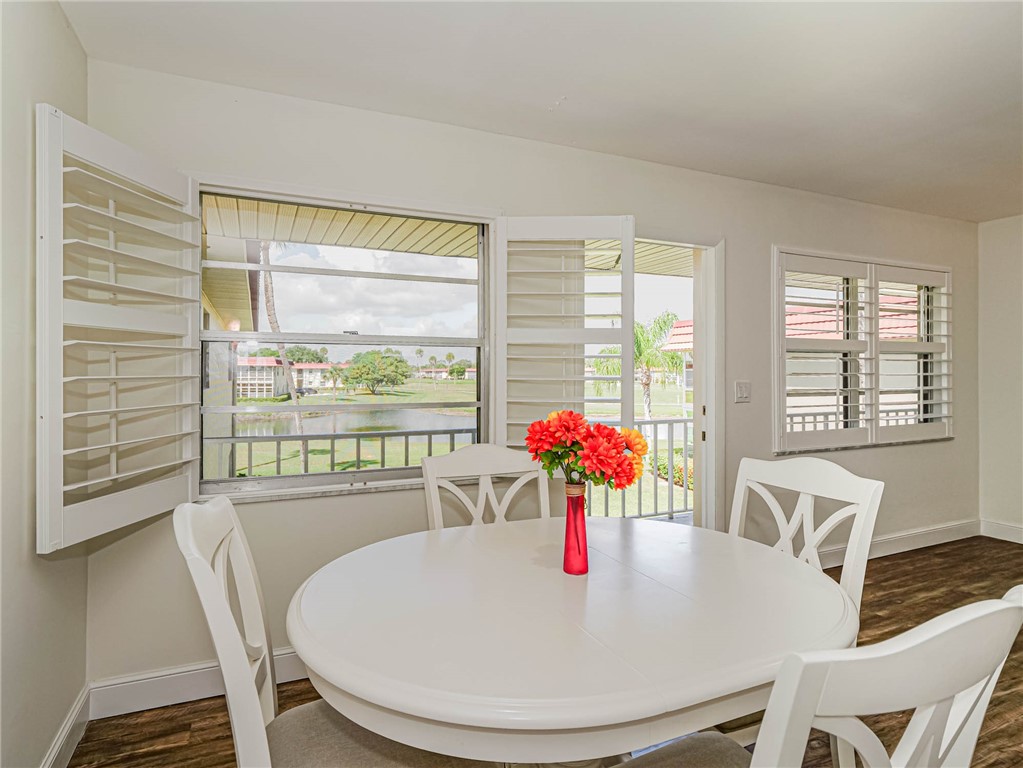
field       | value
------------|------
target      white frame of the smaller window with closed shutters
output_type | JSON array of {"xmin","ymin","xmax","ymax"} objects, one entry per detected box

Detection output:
[{"xmin": 771, "ymin": 245, "xmax": 954, "ymax": 455}]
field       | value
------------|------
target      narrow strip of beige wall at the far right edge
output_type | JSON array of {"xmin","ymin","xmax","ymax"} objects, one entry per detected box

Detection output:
[{"xmin": 978, "ymin": 216, "xmax": 1023, "ymax": 540}]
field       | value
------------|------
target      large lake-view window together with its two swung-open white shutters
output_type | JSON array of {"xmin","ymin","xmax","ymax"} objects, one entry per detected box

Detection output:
[{"xmin": 36, "ymin": 104, "xmax": 633, "ymax": 553}]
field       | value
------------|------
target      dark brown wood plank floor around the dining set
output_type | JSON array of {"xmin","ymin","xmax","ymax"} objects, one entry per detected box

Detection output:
[{"xmin": 71, "ymin": 536, "xmax": 1023, "ymax": 768}]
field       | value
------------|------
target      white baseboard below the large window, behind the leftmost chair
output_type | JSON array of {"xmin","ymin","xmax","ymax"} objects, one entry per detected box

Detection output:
[{"xmin": 89, "ymin": 647, "xmax": 308, "ymax": 720}]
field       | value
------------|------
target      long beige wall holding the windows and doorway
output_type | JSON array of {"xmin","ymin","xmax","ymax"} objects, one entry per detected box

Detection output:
[{"xmin": 83, "ymin": 61, "xmax": 978, "ymax": 678}]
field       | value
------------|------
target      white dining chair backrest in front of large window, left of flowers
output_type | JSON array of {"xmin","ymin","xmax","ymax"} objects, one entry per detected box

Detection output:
[{"xmin": 422, "ymin": 443, "xmax": 550, "ymax": 531}]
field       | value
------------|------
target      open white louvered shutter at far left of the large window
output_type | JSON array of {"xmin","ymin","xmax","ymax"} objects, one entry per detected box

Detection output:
[{"xmin": 36, "ymin": 104, "xmax": 202, "ymax": 553}]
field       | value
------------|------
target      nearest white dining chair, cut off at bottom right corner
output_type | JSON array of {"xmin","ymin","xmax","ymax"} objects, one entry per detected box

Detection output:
[{"xmin": 629, "ymin": 585, "xmax": 1023, "ymax": 768}]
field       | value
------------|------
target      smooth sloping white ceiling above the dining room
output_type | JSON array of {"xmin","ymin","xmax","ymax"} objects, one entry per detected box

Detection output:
[{"xmin": 63, "ymin": 2, "xmax": 1023, "ymax": 221}]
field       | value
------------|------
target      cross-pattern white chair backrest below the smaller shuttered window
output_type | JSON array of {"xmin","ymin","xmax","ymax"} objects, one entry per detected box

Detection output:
[{"xmin": 728, "ymin": 456, "xmax": 885, "ymax": 608}]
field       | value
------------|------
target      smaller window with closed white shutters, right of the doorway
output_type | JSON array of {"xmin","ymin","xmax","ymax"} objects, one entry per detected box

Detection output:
[{"xmin": 774, "ymin": 251, "xmax": 952, "ymax": 453}]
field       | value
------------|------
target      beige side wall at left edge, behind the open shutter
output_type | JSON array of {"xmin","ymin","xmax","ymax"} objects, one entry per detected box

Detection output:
[{"xmin": 0, "ymin": 3, "xmax": 87, "ymax": 768}]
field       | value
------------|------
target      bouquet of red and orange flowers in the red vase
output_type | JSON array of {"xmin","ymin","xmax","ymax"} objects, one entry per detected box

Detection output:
[{"xmin": 526, "ymin": 411, "xmax": 648, "ymax": 491}]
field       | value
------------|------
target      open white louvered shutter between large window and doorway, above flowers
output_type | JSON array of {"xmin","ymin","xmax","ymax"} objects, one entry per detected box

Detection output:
[{"xmin": 495, "ymin": 216, "xmax": 635, "ymax": 447}]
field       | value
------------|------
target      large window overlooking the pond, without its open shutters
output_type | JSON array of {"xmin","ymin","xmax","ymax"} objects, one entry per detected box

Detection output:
[{"xmin": 199, "ymin": 193, "xmax": 486, "ymax": 493}]
